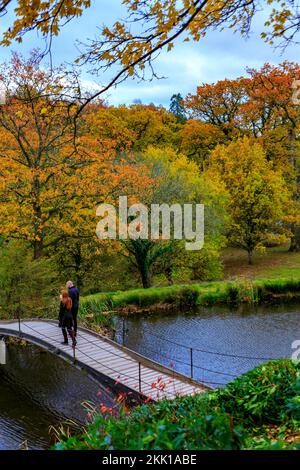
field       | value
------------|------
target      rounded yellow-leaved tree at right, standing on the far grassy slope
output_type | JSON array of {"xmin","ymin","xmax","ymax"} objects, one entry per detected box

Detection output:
[{"xmin": 208, "ymin": 137, "xmax": 293, "ymax": 264}]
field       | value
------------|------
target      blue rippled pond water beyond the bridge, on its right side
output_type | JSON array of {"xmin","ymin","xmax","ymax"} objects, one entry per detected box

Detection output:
[{"xmin": 117, "ymin": 305, "xmax": 300, "ymax": 387}]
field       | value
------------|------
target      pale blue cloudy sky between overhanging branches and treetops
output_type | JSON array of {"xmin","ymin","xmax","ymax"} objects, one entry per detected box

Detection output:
[{"xmin": 0, "ymin": 0, "xmax": 300, "ymax": 108}]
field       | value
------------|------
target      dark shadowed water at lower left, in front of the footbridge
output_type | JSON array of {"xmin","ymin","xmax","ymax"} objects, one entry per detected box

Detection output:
[{"xmin": 0, "ymin": 345, "xmax": 118, "ymax": 450}]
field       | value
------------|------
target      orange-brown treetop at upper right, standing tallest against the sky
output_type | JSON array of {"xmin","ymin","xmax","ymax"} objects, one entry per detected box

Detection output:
[{"xmin": 185, "ymin": 62, "xmax": 300, "ymax": 149}]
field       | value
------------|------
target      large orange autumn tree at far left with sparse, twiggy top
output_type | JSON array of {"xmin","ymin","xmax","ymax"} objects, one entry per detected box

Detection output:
[{"xmin": 0, "ymin": 52, "xmax": 151, "ymax": 263}]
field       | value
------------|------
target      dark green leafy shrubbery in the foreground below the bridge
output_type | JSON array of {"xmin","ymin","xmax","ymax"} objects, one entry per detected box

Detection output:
[{"xmin": 56, "ymin": 360, "xmax": 300, "ymax": 450}]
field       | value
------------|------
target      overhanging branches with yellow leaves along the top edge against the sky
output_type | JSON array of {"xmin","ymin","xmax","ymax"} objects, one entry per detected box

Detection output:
[{"xmin": 1, "ymin": 0, "xmax": 298, "ymax": 68}]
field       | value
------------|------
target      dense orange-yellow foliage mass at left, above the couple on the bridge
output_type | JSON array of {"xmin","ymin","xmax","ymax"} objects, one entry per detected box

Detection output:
[{"xmin": 0, "ymin": 88, "xmax": 155, "ymax": 246}]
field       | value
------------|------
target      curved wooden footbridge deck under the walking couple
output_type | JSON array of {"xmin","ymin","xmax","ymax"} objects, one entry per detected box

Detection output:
[{"xmin": 0, "ymin": 319, "xmax": 209, "ymax": 401}]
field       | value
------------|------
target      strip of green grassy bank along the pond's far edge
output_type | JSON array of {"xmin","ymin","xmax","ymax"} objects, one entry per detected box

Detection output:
[{"xmin": 80, "ymin": 278, "xmax": 300, "ymax": 323}]
